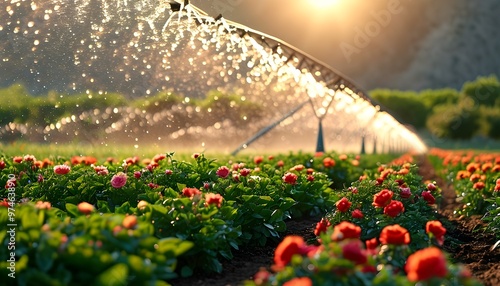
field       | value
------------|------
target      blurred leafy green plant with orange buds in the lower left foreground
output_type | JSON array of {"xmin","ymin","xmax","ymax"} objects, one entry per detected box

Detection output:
[{"xmin": 0, "ymin": 202, "xmax": 193, "ymax": 285}]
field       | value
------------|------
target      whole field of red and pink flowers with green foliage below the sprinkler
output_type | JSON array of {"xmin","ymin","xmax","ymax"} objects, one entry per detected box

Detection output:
[{"xmin": 0, "ymin": 150, "xmax": 500, "ymax": 285}]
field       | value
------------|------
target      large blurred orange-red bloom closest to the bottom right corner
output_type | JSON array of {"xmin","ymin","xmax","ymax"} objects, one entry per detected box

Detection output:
[{"xmin": 405, "ymin": 247, "xmax": 448, "ymax": 282}]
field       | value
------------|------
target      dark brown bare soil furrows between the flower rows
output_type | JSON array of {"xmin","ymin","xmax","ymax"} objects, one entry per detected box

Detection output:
[{"xmin": 170, "ymin": 156, "xmax": 500, "ymax": 286}]
